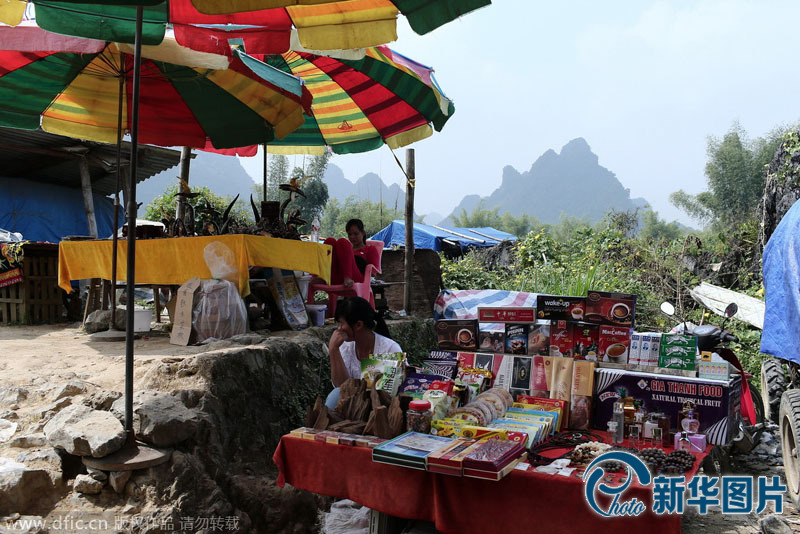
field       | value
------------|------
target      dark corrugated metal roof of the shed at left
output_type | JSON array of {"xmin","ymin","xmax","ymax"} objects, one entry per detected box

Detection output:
[{"xmin": 0, "ymin": 127, "xmax": 181, "ymax": 195}]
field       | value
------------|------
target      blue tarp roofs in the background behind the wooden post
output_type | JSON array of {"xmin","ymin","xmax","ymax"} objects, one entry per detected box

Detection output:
[{"xmin": 370, "ymin": 220, "xmax": 517, "ymax": 250}]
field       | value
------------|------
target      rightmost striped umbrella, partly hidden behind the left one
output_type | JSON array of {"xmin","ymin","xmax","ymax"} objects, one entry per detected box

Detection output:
[{"xmin": 257, "ymin": 46, "xmax": 455, "ymax": 154}]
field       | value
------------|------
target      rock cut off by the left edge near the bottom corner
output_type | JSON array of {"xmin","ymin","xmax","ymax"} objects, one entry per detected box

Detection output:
[{"xmin": 0, "ymin": 457, "xmax": 52, "ymax": 516}]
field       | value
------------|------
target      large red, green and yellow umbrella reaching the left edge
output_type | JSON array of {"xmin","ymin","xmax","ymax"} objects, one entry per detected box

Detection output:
[{"xmin": 0, "ymin": 26, "xmax": 309, "ymax": 148}]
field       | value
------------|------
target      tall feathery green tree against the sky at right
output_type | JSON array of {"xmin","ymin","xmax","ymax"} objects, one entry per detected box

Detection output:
[{"xmin": 670, "ymin": 123, "xmax": 788, "ymax": 230}]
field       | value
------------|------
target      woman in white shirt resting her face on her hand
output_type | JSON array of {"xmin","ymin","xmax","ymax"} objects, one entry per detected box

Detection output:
[{"xmin": 325, "ymin": 297, "xmax": 403, "ymax": 410}]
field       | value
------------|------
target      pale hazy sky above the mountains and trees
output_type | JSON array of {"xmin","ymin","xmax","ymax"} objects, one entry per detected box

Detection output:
[{"xmin": 242, "ymin": 0, "xmax": 800, "ymax": 223}]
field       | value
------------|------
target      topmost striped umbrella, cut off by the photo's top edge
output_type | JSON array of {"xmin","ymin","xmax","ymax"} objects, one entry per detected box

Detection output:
[{"xmin": 0, "ymin": 0, "xmax": 491, "ymax": 54}]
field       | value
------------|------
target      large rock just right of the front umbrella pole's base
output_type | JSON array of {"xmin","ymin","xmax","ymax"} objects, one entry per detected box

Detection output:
[{"xmin": 111, "ymin": 390, "xmax": 199, "ymax": 447}]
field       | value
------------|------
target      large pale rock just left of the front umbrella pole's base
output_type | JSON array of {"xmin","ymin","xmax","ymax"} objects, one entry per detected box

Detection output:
[{"xmin": 44, "ymin": 405, "xmax": 125, "ymax": 458}]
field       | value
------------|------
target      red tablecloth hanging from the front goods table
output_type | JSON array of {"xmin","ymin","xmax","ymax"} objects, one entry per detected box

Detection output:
[{"xmin": 273, "ymin": 436, "xmax": 703, "ymax": 534}]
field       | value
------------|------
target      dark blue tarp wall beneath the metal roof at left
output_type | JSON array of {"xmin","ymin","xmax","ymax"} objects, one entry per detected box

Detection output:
[{"xmin": 0, "ymin": 178, "xmax": 115, "ymax": 243}]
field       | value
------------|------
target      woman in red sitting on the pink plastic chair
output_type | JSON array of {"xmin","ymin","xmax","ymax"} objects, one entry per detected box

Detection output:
[{"xmin": 325, "ymin": 219, "xmax": 380, "ymax": 287}]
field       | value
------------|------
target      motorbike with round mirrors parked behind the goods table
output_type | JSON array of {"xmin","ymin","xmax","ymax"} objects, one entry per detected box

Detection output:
[{"xmin": 661, "ymin": 302, "xmax": 766, "ymax": 476}]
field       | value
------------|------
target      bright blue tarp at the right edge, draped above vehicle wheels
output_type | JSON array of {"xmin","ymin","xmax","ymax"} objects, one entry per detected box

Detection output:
[{"xmin": 761, "ymin": 201, "xmax": 800, "ymax": 363}]
